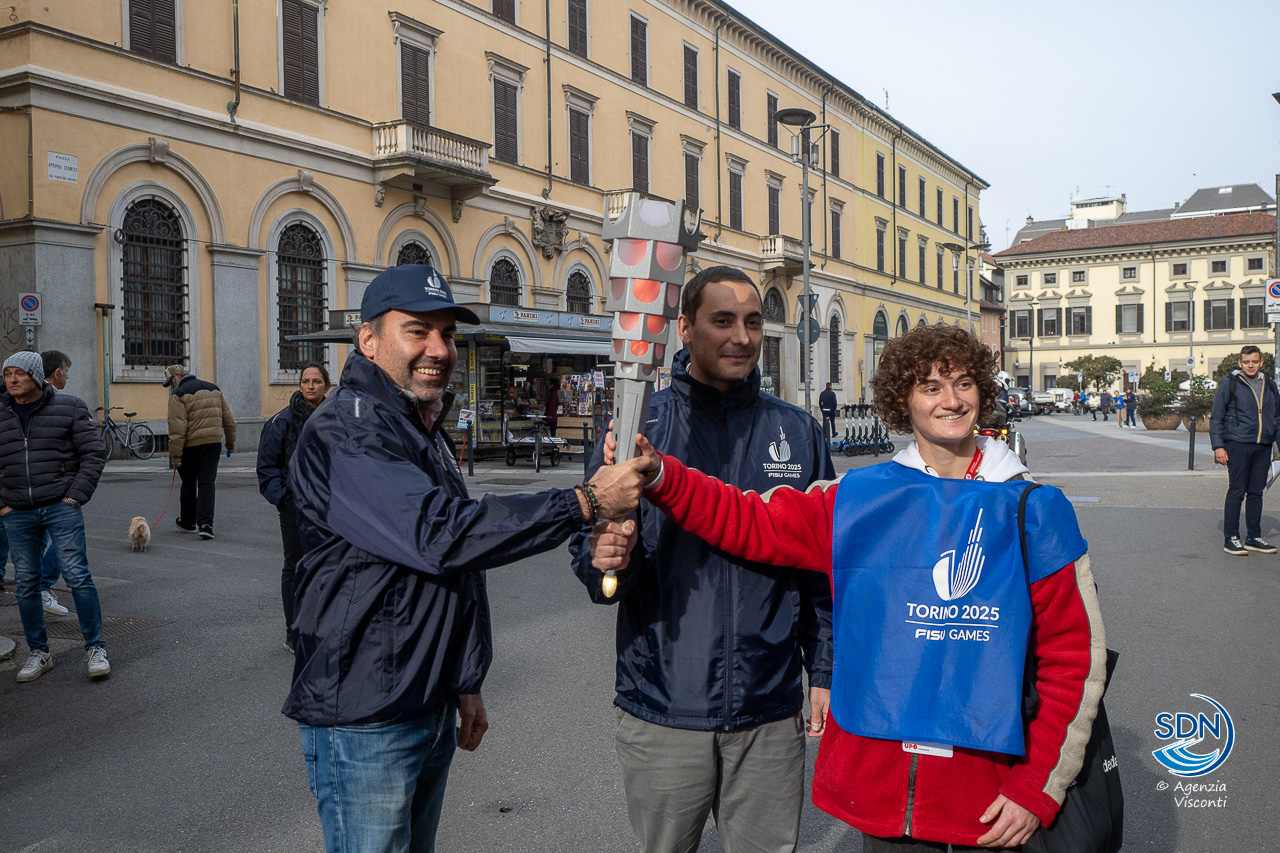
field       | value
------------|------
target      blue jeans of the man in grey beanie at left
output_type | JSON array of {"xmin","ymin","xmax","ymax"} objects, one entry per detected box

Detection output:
[{"xmin": 4, "ymin": 501, "xmax": 104, "ymax": 652}]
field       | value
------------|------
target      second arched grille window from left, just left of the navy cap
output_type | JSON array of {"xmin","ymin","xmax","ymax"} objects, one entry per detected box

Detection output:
[{"xmin": 275, "ymin": 222, "xmax": 329, "ymax": 370}]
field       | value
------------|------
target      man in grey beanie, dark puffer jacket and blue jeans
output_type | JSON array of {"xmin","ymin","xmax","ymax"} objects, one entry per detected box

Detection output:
[{"xmin": 0, "ymin": 351, "xmax": 111, "ymax": 681}]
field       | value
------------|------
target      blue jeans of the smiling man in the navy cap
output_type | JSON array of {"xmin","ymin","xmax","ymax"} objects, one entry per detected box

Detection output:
[{"xmin": 298, "ymin": 702, "xmax": 457, "ymax": 853}]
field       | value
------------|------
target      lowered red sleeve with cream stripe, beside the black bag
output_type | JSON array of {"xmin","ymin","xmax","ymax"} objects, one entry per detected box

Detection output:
[{"xmin": 1000, "ymin": 555, "xmax": 1107, "ymax": 825}]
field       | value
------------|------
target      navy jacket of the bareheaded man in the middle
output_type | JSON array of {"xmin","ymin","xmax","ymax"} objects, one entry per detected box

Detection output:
[{"xmin": 572, "ymin": 351, "xmax": 836, "ymax": 731}]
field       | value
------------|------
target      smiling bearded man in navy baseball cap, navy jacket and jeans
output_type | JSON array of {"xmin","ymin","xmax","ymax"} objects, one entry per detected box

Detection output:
[{"xmin": 283, "ymin": 265, "xmax": 645, "ymax": 850}]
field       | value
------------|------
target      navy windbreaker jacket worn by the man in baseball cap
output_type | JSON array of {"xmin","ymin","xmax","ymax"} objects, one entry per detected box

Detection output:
[{"xmin": 283, "ymin": 352, "xmax": 582, "ymax": 726}]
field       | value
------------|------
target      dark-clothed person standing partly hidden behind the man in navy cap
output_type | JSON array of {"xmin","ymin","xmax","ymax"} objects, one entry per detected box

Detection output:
[{"xmin": 257, "ymin": 361, "xmax": 332, "ymax": 653}]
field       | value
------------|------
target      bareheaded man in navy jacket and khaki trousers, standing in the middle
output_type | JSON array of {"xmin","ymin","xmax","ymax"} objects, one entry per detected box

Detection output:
[{"xmin": 573, "ymin": 266, "xmax": 835, "ymax": 853}]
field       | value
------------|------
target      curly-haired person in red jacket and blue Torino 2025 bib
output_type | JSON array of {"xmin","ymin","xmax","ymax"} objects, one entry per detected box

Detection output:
[{"xmin": 595, "ymin": 325, "xmax": 1106, "ymax": 853}]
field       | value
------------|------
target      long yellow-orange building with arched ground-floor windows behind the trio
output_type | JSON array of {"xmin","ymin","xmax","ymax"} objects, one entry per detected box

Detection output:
[{"xmin": 0, "ymin": 0, "xmax": 987, "ymax": 447}]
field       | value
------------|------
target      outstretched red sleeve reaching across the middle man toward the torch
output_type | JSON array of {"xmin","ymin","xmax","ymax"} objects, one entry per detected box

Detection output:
[{"xmin": 645, "ymin": 456, "xmax": 838, "ymax": 575}]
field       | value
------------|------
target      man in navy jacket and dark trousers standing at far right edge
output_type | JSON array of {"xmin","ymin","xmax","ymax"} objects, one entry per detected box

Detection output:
[{"xmin": 1208, "ymin": 345, "xmax": 1280, "ymax": 557}]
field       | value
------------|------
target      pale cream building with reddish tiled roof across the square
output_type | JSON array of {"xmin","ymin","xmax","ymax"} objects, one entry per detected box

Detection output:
[{"xmin": 995, "ymin": 213, "xmax": 1276, "ymax": 389}]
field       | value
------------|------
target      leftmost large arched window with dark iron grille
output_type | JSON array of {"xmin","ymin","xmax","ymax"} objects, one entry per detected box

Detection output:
[{"xmin": 115, "ymin": 199, "xmax": 187, "ymax": 366}]
